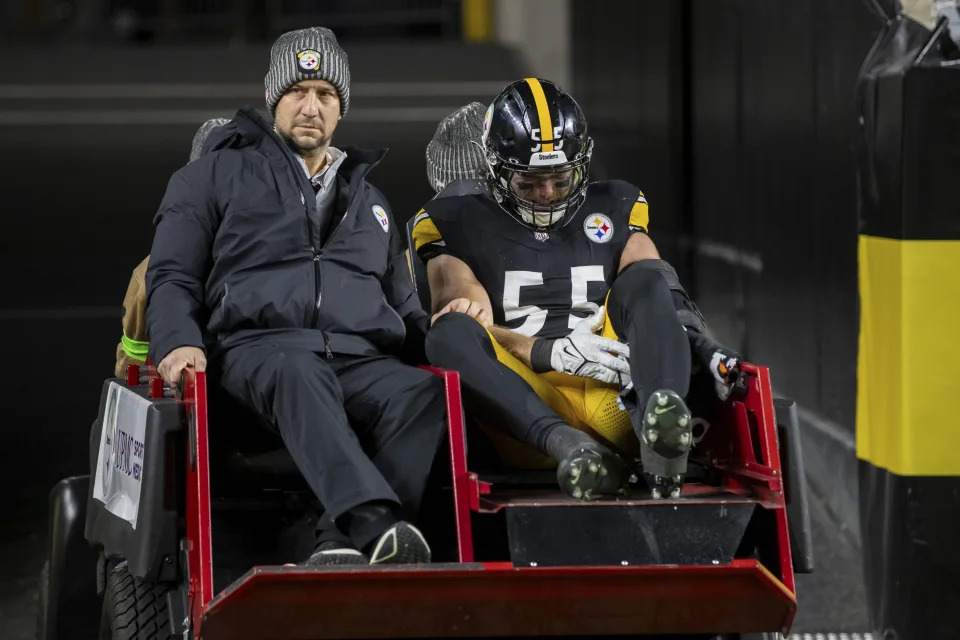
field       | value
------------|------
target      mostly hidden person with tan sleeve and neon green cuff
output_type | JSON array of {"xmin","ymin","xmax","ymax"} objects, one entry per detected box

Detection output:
[{"xmin": 113, "ymin": 118, "xmax": 229, "ymax": 378}]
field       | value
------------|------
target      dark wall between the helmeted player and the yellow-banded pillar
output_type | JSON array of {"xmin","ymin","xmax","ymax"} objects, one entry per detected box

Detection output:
[{"xmin": 573, "ymin": 0, "xmax": 893, "ymax": 538}]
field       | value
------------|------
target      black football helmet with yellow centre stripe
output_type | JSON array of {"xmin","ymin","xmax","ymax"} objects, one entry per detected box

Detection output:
[{"xmin": 482, "ymin": 78, "xmax": 593, "ymax": 231}]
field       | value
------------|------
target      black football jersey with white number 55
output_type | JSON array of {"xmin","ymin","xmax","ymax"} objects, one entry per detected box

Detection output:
[{"xmin": 413, "ymin": 180, "xmax": 649, "ymax": 338}]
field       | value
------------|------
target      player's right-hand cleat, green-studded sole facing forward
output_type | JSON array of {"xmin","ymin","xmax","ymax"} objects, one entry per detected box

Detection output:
[{"xmin": 638, "ymin": 389, "xmax": 693, "ymax": 499}]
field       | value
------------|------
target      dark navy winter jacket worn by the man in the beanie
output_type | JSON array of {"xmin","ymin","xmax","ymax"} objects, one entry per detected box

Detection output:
[{"xmin": 147, "ymin": 109, "xmax": 427, "ymax": 362}]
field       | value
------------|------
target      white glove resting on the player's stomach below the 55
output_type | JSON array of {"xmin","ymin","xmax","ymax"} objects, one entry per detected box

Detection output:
[{"xmin": 550, "ymin": 307, "xmax": 630, "ymax": 386}]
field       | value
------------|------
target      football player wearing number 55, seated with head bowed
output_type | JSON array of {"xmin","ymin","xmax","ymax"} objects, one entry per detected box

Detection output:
[{"xmin": 412, "ymin": 78, "xmax": 738, "ymax": 499}]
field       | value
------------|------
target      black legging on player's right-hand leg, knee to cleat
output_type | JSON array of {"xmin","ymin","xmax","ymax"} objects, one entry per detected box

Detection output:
[{"xmin": 607, "ymin": 260, "xmax": 690, "ymax": 410}]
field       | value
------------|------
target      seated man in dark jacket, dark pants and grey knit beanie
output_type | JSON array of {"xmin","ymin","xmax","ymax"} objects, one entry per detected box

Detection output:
[{"xmin": 147, "ymin": 28, "xmax": 476, "ymax": 564}]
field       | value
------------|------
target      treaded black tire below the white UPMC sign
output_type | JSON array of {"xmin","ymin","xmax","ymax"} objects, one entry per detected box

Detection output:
[{"xmin": 100, "ymin": 562, "xmax": 177, "ymax": 640}]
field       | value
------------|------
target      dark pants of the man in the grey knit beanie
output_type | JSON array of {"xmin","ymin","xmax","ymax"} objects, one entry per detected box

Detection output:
[{"xmin": 217, "ymin": 342, "xmax": 446, "ymax": 547}]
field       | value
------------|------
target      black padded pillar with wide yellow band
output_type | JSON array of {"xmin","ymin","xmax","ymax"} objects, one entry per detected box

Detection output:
[{"xmin": 857, "ymin": 16, "xmax": 960, "ymax": 640}]
